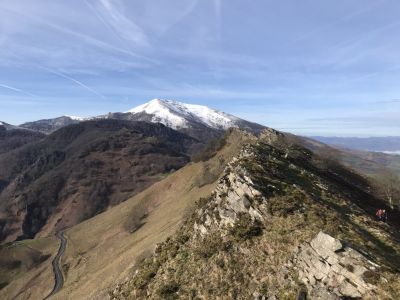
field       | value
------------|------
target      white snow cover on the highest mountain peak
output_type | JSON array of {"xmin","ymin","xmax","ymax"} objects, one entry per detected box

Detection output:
[{"xmin": 127, "ymin": 99, "xmax": 241, "ymax": 130}]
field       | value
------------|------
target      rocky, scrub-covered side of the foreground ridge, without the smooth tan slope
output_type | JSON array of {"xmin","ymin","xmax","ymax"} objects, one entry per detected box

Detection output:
[{"xmin": 110, "ymin": 131, "xmax": 400, "ymax": 299}]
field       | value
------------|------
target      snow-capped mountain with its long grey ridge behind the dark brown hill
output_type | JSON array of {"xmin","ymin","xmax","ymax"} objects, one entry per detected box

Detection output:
[{"xmin": 19, "ymin": 99, "xmax": 265, "ymax": 139}]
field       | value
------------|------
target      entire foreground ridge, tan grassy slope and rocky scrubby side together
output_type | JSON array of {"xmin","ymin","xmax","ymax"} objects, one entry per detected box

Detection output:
[{"xmin": 0, "ymin": 130, "xmax": 400, "ymax": 299}]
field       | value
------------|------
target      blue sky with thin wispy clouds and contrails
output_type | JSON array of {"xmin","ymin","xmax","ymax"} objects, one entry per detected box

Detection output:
[{"xmin": 0, "ymin": 0, "xmax": 400, "ymax": 136}]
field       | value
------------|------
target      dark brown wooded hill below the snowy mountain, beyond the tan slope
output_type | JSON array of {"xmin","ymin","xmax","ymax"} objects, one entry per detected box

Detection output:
[{"xmin": 0, "ymin": 120, "xmax": 202, "ymax": 241}]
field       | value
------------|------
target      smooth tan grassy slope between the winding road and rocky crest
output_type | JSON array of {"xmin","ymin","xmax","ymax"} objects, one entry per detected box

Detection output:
[{"xmin": 0, "ymin": 131, "xmax": 253, "ymax": 299}]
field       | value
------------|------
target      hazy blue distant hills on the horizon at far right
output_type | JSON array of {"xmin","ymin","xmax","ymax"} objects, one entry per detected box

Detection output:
[{"xmin": 311, "ymin": 136, "xmax": 400, "ymax": 154}]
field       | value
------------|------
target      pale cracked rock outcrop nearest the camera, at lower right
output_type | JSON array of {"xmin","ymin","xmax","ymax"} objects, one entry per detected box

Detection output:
[{"xmin": 293, "ymin": 232, "xmax": 377, "ymax": 300}]
